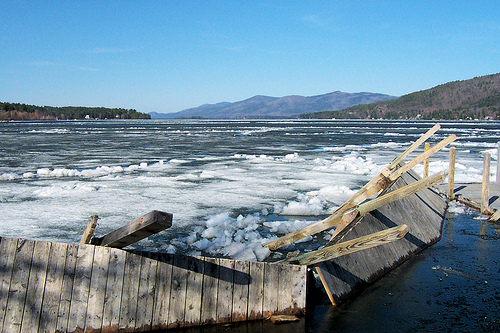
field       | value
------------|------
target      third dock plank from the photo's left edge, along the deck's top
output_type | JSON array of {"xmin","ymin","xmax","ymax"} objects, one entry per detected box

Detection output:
[{"xmin": 21, "ymin": 241, "xmax": 51, "ymax": 332}]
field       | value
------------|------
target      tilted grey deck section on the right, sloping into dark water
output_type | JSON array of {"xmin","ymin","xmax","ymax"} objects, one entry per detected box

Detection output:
[{"xmin": 316, "ymin": 171, "xmax": 447, "ymax": 305}]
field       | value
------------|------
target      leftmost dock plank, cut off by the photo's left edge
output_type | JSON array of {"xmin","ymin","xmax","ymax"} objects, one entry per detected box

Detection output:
[{"xmin": 0, "ymin": 238, "xmax": 17, "ymax": 332}]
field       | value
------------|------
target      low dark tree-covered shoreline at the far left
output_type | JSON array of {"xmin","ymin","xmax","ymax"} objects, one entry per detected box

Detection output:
[{"xmin": 0, "ymin": 103, "xmax": 150, "ymax": 120}]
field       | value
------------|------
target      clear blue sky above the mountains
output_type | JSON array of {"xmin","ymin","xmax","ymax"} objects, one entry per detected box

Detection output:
[{"xmin": 0, "ymin": 0, "xmax": 500, "ymax": 112}]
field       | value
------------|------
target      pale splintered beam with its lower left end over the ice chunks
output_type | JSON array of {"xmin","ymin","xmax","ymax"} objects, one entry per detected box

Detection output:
[{"xmin": 264, "ymin": 209, "xmax": 359, "ymax": 251}]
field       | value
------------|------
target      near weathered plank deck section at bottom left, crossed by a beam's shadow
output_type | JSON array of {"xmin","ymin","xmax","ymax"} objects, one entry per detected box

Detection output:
[{"xmin": 0, "ymin": 238, "xmax": 307, "ymax": 333}]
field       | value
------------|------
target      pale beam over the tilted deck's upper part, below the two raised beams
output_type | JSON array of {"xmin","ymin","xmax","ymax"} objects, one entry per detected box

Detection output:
[{"xmin": 358, "ymin": 171, "xmax": 446, "ymax": 216}]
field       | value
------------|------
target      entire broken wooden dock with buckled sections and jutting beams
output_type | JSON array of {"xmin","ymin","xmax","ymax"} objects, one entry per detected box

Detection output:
[{"xmin": 0, "ymin": 125, "xmax": 492, "ymax": 332}]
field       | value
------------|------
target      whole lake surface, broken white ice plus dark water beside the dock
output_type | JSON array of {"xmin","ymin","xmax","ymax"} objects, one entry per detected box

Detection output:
[{"xmin": 0, "ymin": 120, "xmax": 500, "ymax": 332}]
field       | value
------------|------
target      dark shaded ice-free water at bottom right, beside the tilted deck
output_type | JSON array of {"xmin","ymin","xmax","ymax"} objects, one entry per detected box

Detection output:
[{"xmin": 160, "ymin": 212, "xmax": 500, "ymax": 333}]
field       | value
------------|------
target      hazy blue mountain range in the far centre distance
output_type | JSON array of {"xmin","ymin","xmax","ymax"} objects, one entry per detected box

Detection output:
[{"xmin": 150, "ymin": 91, "xmax": 397, "ymax": 119}]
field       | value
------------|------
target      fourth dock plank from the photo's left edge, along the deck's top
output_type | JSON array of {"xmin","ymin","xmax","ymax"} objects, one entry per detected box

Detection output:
[{"xmin": 38, "ymin": 243, "xmax": 68, "ymax": 332}]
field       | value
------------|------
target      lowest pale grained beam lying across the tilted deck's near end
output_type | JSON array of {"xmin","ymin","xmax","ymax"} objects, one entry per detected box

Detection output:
[{"xmin": 285, "ymin": 224, "xmax": 410, "ymax": 266}]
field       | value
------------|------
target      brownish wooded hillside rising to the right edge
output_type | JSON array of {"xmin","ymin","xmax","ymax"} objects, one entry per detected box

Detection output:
[{"xmin": 301, "ymin": 73, "xmax": 500, "ymax": 120}]
